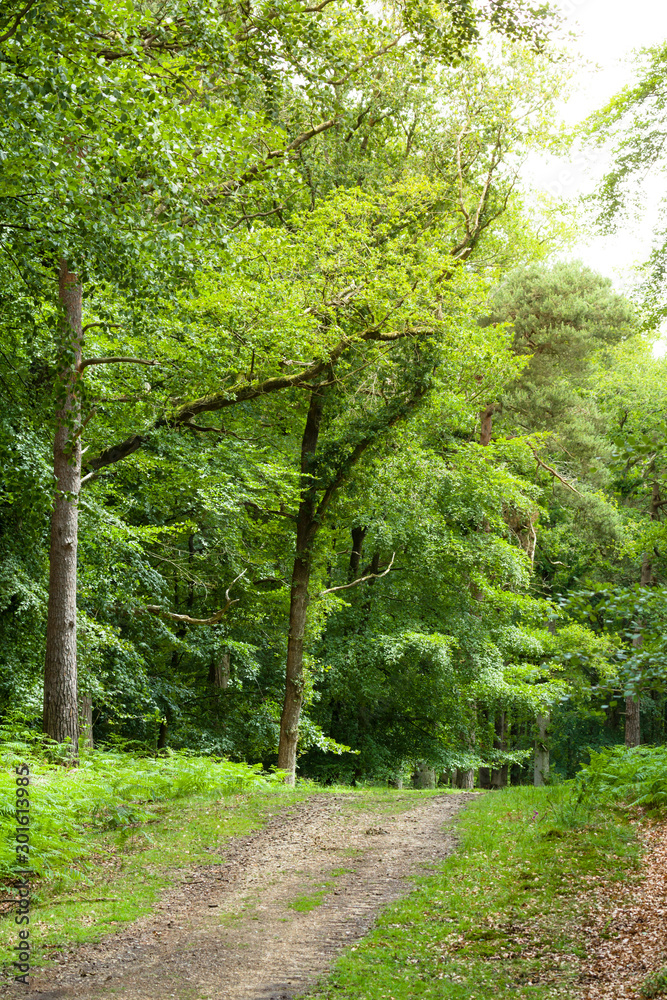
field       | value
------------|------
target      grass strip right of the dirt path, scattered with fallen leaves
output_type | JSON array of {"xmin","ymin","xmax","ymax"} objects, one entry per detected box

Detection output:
[{"xmin": 309, "ymin": 787, "xmax": 639, "ymax": 1000}]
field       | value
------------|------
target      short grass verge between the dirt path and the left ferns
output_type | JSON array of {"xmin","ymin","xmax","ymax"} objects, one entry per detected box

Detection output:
[{"xmin": 0, "ymin": 786, "xmax": 309, "ymax": 968}]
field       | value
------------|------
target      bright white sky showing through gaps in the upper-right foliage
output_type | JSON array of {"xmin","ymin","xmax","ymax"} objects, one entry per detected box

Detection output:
[{"xmin": 530, "ymin": 0, "xmax": 667, "ymax": 290}]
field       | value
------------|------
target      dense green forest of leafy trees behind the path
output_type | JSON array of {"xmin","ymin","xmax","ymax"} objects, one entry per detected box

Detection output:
[{"xmin": 0, "ymin": 0, "xmax": 667, "ymax": 788}]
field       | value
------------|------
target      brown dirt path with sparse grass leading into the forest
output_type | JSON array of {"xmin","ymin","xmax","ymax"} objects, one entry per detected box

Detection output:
[{"xmin": 7, "ymin": 793, "xmax": 470, "ymax": 1000}]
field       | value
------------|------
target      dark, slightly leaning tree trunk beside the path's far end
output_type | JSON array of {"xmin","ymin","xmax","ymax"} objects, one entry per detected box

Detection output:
[{"xmin": 278, "ymin": 388, "xmax": 324, "ymax": 785}]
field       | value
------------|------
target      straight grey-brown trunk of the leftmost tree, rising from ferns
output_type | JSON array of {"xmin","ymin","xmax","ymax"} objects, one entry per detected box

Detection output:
[{"xmin": 43, "ymin": 261, "xmax": 83, "ymax": 755}]
